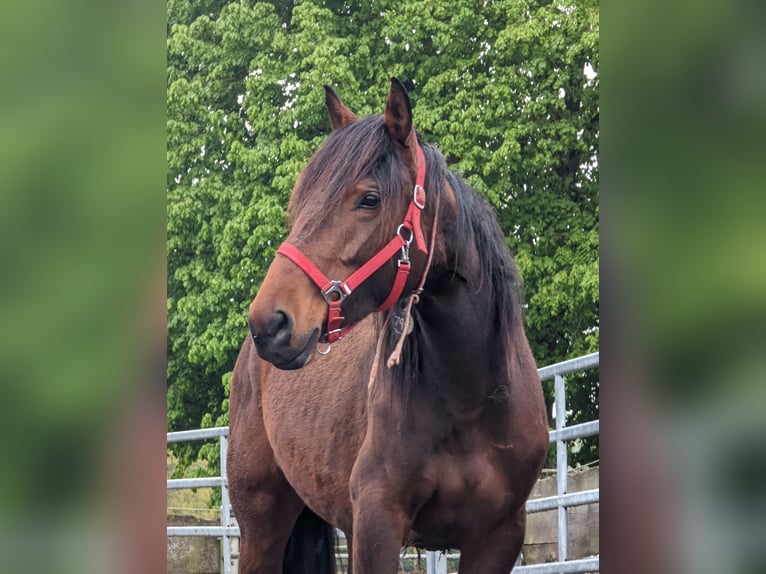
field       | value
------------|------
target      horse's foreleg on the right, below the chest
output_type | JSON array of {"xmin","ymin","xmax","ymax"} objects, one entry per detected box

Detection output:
[{"xmin": 458, "ymin": 508, "xmax": 527, "ymax": 574}]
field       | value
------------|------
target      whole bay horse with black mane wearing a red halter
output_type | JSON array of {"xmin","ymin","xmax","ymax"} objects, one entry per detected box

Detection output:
[{"xmin": 227, "ymin": 78, "xmax": 548, "ymax": 574}]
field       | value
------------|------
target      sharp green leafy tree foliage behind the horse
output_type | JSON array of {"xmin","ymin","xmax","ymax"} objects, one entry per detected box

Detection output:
[{"xmin": 167, "ymin": 0, "xmax": 599, "ymax": 470}]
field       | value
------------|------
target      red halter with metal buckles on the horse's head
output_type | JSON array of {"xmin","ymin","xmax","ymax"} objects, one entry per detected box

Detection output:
[{"xmin": 277, "ymin": 143, "xmax": 428, "ymax": 343}]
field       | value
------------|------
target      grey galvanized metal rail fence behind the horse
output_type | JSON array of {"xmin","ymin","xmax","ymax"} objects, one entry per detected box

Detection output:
[{"xmin": 167, "ymin": 353, "xmax": 599, "ymax": 574}]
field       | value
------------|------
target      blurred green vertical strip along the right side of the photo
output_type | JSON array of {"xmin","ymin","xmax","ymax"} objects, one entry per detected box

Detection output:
[{"xmin": 601, "ymin": 1, "xmax": 766, "ymax": 574}]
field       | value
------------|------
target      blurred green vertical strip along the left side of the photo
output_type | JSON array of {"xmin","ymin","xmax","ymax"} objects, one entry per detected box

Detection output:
[{"xmin": 0, "ymin": 0, "xmax": 165, "ymax": 573}]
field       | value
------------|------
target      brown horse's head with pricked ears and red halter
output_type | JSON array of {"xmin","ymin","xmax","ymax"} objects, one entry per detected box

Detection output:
[{"xmin": 248, "ymin": 79, "xmax": 433, "ymax": 369}]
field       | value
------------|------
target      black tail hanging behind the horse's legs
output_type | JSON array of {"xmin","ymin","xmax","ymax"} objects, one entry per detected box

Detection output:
[{"xmin": 282, "ymin": 506, "xmax": 335, "ymax": 574}]
